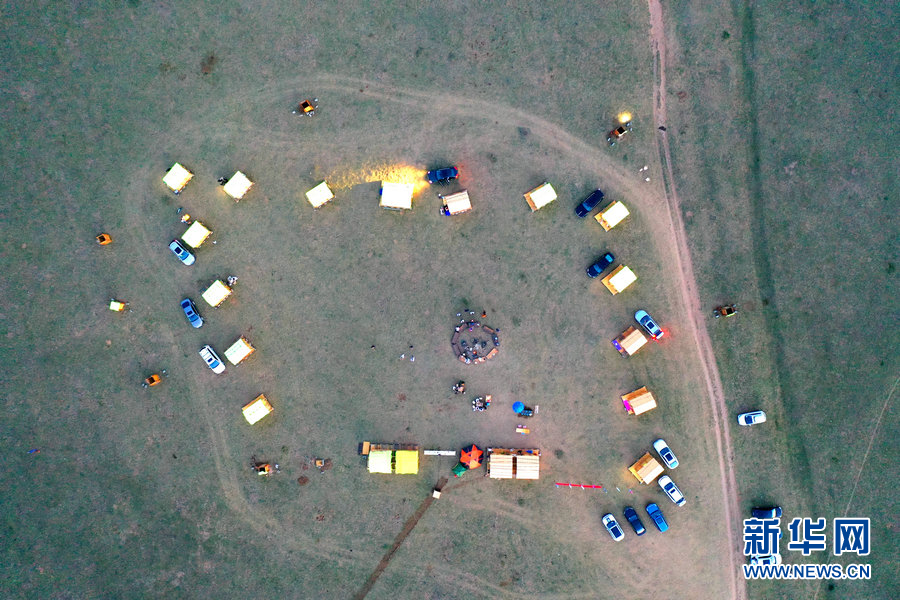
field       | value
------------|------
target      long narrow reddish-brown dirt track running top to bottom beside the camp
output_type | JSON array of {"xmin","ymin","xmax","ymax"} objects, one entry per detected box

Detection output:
[{"xmin": 648, "ymin": 0, "xmax": 747, "ymax": 600}]
